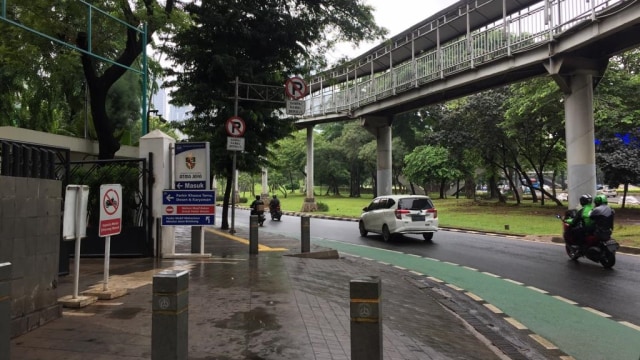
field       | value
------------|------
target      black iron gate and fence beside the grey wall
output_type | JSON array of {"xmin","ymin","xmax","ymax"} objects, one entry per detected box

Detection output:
[{"xmin": 0, "ymin": 139, "xmax": 154, "ymax": 274}]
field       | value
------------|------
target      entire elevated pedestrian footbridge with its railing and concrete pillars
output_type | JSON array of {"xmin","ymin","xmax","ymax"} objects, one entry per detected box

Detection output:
[{"xmin": 297, "ymin": 0, "xmax": 640, "ymax": 209}]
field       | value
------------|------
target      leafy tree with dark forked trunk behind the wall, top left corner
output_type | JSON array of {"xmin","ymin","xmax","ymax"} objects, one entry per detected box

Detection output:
[{"xmin": 0, "ymin": 0, "xmax": 180, "ymax": 159}]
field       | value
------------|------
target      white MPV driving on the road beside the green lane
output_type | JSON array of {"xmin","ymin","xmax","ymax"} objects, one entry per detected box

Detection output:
[{"xmin": 359, "ymin": 195, "xmax": 438, "ymax": 241}]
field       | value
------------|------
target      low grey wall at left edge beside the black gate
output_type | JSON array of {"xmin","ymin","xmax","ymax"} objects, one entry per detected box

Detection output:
[{"xmin": 0, "ymin": 176, "xmax": 62, "ymax": 337}]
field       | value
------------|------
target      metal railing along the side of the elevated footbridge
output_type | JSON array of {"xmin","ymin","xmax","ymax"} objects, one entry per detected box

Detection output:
[{"xmin": 304, "ymin": 0, "xmax": 629, "ymax": 118}]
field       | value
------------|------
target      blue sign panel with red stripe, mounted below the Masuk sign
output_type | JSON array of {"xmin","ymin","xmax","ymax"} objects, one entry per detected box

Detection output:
[{"xmin": 162, "ymin": 190, "xmax": 216, "ymax": 226}]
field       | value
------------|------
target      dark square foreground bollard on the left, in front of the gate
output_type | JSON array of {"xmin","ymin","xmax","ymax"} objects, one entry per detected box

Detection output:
[{"xmin": 151, "ymin": 270, "xmax": 189, "ymax": 360}]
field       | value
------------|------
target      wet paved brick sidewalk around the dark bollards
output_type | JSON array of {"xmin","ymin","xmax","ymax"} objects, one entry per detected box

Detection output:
[{"xmin": 11, "ymin": 228, "xmax": 545, "ymax": 360}]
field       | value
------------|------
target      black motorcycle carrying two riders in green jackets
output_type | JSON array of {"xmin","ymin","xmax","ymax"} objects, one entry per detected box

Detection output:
[{"xmin": 556, "ymin": 210, "xmax": 620, "ymax": 269}]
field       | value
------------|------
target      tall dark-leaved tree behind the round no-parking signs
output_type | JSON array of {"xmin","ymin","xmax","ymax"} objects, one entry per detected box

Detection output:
[{"xmin": 164, "ymin": 0, "xmax": 384, "ymax": 229}]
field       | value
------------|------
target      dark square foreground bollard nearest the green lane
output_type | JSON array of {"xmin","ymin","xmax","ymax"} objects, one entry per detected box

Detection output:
[{"xmin": 349, "ymin": 276, "xmax": 382, "ymax": 360}]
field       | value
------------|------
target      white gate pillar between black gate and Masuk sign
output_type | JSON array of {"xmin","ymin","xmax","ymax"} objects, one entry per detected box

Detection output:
[{"xmin": 139, "ymin": 130, "xmax": 176, "ymax": 256}]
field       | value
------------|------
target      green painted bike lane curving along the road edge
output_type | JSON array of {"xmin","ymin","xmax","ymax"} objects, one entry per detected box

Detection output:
[{"xmin": 312, "ymin": 238, "xmax": 640, "ymax": 360}]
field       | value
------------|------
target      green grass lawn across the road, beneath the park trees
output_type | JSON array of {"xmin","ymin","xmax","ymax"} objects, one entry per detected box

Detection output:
[{"xmin": 278, "ymin": 193, "xmax": 640, "ymax": 247}]
